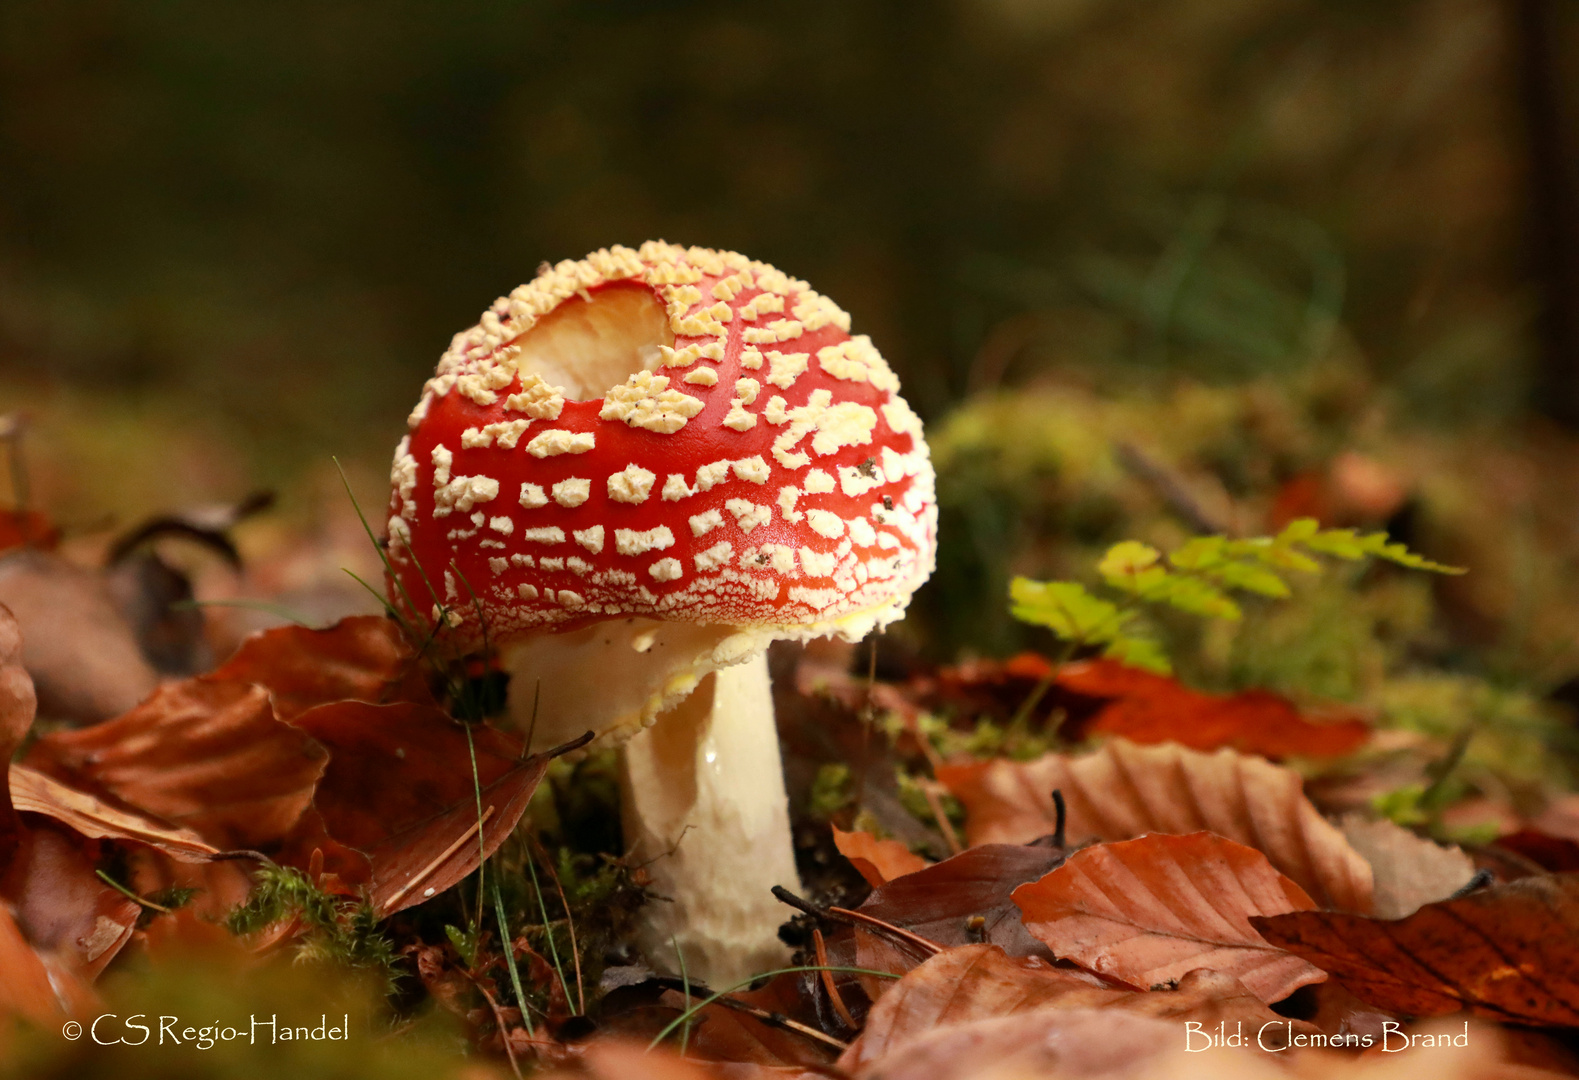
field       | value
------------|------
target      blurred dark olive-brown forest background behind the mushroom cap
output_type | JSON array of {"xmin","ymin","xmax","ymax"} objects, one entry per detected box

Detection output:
[{"xmin": 0, "ymin": 0, "xmax": 1579, "ymax": 669}]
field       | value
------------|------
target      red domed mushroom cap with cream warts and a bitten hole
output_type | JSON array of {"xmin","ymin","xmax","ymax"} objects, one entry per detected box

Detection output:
[{"xmin": 388, "ymin": 242, "xmax": 936, "ymax": 663}]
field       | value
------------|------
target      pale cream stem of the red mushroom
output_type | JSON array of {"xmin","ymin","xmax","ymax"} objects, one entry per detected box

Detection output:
[{"xmin": 621, "ymin": 654, "xmax": 799, "ymax": 985}]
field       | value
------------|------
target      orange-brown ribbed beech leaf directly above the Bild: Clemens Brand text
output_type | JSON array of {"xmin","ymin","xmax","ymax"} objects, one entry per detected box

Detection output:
[{"xmin": 1014, "ymin": 832, "xmax": 1326, "ymax": 1003}]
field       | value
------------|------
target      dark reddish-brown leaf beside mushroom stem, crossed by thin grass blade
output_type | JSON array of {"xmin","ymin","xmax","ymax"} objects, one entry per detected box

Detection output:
[{"xmin": 295, "ymin": 701, "xmax": 570, "ymax": 916}]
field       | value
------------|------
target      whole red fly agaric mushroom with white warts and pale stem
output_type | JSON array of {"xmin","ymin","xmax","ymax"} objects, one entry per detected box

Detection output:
[{"xmin": 388, "ymin": 242, "xmax": 936, "ymax": 984}]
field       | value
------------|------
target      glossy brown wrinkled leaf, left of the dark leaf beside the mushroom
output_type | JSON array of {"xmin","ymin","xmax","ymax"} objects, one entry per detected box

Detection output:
[{"xmin": 27, "ymin": 677, "xmax": 324, "ymax": 848}]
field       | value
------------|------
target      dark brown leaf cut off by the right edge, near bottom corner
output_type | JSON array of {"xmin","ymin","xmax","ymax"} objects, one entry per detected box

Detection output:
[{"xmin": 1254, "ymin": 873, "xmax": 1579, "ymax": 1028}]
